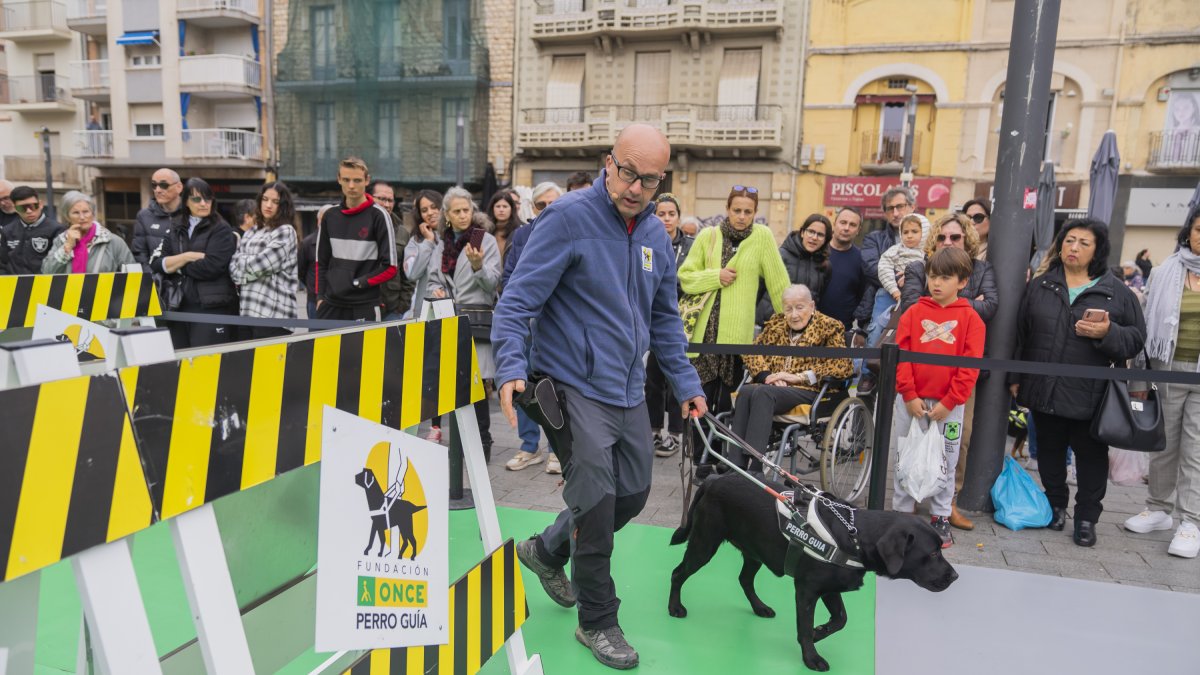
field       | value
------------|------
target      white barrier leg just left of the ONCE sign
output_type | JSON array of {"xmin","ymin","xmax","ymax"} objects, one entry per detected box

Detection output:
[{"xmin": 169, "ymin": 504, "xmax": 254, "ymax": 673}]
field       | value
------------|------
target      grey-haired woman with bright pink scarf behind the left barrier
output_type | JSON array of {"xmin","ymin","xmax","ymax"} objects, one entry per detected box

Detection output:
[{"xmin": 42, "ymin": 190, "xmax": 137, "ymax": 274}]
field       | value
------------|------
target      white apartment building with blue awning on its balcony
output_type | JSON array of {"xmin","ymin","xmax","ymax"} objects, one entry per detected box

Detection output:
[{"xmin": 44, "ymin": 0, "xmax": 271, "ymax": 236}]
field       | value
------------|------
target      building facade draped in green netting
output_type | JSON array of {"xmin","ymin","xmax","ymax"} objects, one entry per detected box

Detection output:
[{"xmin": 272, "ymin": 0, "xmax": 492, "ymax": 201}]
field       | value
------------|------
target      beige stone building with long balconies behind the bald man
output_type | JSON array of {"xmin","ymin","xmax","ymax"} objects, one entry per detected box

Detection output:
[{"xmin": 512, "ymin": 0, "xmax": 805, "ymax": 238}]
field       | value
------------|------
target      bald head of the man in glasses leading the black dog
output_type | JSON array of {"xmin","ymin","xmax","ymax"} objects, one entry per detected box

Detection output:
[{"xmin": 605, "ymin": 124, "xmax": 671, "ymax": 219}]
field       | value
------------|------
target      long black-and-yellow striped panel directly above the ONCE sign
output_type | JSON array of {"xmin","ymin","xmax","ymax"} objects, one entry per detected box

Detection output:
[{"xmin": 120, "ymin": 317, "xmax": 484, "ymax": 519}]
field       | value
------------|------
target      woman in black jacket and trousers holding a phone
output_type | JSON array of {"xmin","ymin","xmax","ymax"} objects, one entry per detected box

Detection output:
[{"xmin": 1009, "ymin": 219, "xmax": 1146, "ymax": 546}]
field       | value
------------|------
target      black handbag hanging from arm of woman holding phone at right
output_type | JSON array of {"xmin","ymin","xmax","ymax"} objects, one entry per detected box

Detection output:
[{"xmin": 1092, "ymin": 356, "xmax": 1166, "ymax": 453}]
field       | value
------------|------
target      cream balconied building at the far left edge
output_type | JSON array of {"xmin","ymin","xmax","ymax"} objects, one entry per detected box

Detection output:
[{"xmin": 0, "ymin": 0, "xmax": 84, "ymax": 205}]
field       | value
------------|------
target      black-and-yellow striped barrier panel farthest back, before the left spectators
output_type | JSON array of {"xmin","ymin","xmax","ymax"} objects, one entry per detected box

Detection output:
[{"xmin": 0, "ymin": 271, "xmax": 162, "ymax": 330}]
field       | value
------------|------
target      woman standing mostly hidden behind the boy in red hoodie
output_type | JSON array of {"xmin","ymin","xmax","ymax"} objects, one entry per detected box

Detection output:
[{"xmin": 900, "ymin": 214, "xmax": 1000, "ymax": 530}]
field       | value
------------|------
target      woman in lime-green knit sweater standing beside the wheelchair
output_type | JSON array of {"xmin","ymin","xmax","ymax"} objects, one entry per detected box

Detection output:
[{"xmin": 679, "ymin": 185, "xmax": 791, "ymax": 461}]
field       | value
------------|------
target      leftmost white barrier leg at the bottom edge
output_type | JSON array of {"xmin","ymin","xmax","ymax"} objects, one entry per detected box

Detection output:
[{"xmin": 71, "ymin": 539, "xmax": 162, "ymax": 675}]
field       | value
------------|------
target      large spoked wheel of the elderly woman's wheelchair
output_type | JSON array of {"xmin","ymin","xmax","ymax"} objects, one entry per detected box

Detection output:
[{"xmin": 821, "ymin": 398, "xmax": 875, "ymax": 502}]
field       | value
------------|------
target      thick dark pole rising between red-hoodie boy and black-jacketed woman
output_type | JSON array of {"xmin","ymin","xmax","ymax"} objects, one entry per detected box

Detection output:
[{"xmin": 959, "ymin": 0, "xmax": 1060, "ymax": 510}]
